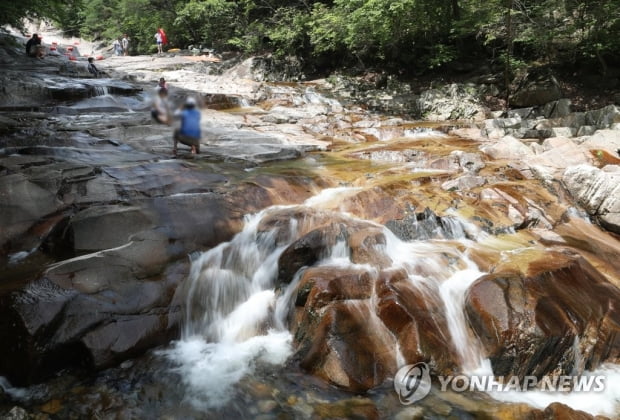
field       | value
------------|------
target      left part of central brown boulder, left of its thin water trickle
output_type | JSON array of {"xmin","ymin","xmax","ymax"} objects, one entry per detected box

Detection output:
[{"xmin": 293, "ymin": 267, "xmax": 396, "ymax": 391}]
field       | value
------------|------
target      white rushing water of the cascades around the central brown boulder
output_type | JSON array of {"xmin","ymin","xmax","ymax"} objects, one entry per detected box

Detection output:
[{"xmin": 163, "ymin": 188, "xmax": 620, "ymax": 412}]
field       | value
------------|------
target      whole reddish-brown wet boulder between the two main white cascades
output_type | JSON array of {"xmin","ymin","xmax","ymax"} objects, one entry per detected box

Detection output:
[{"xmin": 290, "ymin": 266, "xmax": 459, "ymax": 392}]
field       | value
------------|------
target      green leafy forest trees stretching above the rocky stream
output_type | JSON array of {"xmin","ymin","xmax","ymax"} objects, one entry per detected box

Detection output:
[{"xmin": 0, "ymin": 0, "xmax": 620, "ymax": 73}]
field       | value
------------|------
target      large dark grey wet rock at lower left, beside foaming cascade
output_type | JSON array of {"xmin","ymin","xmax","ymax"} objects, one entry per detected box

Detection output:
[{"xmin": 0, "ymin": 260, "xmax": 187, "ymax": 385}]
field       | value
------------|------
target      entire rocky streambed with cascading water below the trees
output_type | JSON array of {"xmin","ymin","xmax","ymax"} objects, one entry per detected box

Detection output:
[{"xmin": 0, "ymin": 27, "xmax": 620, "ymax": 419}]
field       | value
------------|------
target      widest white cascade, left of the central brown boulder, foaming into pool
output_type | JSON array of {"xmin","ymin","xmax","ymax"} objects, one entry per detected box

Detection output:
[{"xmin": 164, "ymin": 207, "xmax": 294, "ymax": 409}]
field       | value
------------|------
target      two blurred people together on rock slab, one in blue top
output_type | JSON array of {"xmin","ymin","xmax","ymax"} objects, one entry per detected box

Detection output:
[{"xmin": 151, "ymin": 77, "xmax": 201, "ymax": 156}]
